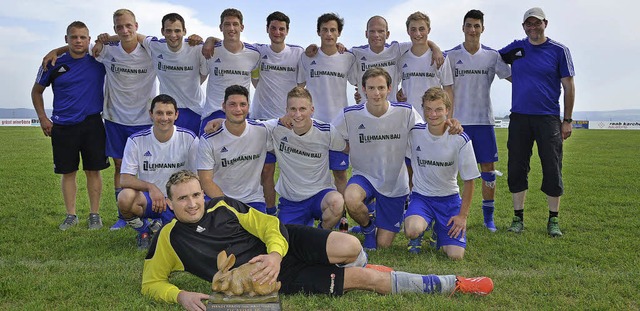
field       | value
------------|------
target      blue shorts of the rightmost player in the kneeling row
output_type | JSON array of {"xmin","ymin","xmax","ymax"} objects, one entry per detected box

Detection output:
[{"xmin": 405, "ymin": 192, "xmax": 467, "ymax": 248}]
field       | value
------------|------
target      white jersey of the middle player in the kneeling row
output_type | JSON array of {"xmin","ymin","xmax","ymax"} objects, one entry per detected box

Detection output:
[{"xmin": 266, "ymin": 120, "xmax": 347, "ymax": 202}]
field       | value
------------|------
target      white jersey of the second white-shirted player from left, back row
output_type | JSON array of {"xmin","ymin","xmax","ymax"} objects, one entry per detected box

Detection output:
[{"xmin": 142, "ymin": 37, "xmax": 207, "ymax": 114}]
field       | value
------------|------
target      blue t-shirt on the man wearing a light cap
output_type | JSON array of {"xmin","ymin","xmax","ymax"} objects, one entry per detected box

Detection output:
[{"xmin": 499, "ymin": 38, "xmax": 575, "ymax": 115}]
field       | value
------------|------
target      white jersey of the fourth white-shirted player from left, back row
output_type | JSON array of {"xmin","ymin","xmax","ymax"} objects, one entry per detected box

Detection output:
[{"xmin": 251, "ymin": 44, "xmax": 304, "ymax": 119}]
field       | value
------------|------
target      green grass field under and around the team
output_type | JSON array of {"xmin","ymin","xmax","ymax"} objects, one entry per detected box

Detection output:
[{"xmin": 0, "ymin": 127, "xmax": 640, "ymax": 310}]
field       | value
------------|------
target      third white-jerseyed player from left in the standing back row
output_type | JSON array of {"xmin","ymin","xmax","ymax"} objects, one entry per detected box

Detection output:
[{"xmin": 199, "ymin": 9, "xmax": 260, "ymax": 135}]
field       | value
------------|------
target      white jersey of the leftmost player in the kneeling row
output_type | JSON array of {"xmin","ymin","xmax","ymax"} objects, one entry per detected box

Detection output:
[{"xmin": 120, "ymin": 126, "xmax": 198, "ymax": 196}]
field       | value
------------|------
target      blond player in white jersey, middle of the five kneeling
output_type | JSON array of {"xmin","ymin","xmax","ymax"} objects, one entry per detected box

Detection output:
[{"xmin": 267, "ymin": 86, "xmax": 347, "ymax": 230}]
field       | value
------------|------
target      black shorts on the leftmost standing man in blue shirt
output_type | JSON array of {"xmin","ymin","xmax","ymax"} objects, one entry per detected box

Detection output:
[{"xmin": 51, "ymin": 114, "xmax": 109, "ymax": 174}]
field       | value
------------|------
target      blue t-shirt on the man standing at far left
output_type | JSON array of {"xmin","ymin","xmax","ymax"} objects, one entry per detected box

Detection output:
[{"xmin": 36, "ymin": 53, "xmax": 105, "ymax": 125}]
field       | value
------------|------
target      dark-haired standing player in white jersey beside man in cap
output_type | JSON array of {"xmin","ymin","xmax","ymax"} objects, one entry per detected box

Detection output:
[{"xmin": 444, "ymin": 10, "xmax": 511, "ymax": 232}]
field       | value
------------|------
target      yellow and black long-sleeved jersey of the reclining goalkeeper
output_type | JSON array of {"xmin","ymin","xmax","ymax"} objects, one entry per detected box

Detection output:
[{"xmin": 142, "ymin": 197, "xmax": 289, "ymax": 303}]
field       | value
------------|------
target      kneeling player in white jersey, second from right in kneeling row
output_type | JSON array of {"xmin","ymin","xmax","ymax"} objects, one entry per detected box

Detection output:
[{"xmin": 334, "ymin": 68, "xmax": 420, "ymax": 249}]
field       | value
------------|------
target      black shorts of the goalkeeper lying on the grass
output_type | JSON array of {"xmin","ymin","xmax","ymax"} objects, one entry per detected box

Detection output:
[{"xmin": 278, "ymin": 225, "xmax": 344, "ymax": 296}]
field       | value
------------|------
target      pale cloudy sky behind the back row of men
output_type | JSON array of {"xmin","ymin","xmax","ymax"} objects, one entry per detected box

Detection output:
[{"xmin": 0, "ymin": 0, "xmax": 640, "ymax": 116}]
